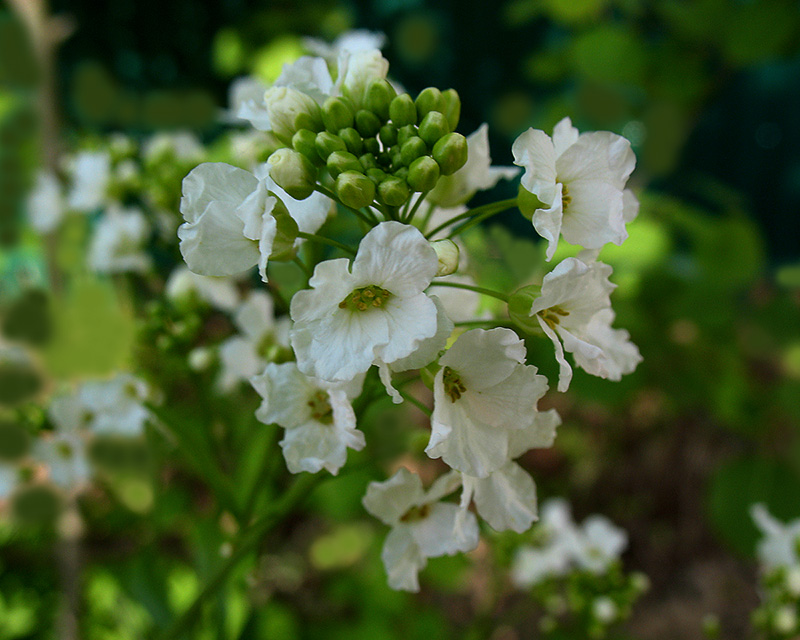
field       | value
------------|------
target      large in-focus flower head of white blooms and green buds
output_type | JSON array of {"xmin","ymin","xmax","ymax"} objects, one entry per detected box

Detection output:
[{"xmin": 178, "ymin": 40, "xmax": 641, "ymax": 590}]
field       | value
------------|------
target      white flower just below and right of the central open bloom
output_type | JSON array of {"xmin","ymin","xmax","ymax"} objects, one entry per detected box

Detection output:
[{"xmin": 425, "ymin": 328, "xmax": 547, "ymax": 478}]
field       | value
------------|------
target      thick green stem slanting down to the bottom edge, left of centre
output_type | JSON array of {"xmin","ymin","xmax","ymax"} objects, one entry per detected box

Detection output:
[{"xmin": 161, "ymin": 474, "xmax": 320, "ymax": 640}]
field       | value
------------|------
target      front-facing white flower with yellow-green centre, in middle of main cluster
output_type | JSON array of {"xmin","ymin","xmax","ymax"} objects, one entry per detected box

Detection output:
[{"xmin": 291, "ymin": 222, "xmax": 438, "ymax": 382}]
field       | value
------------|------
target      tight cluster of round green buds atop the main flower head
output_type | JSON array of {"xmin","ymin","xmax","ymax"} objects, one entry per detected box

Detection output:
[{"xmin": 266, "ymin": 79, "xmax": 467, "ymax": 209}]
